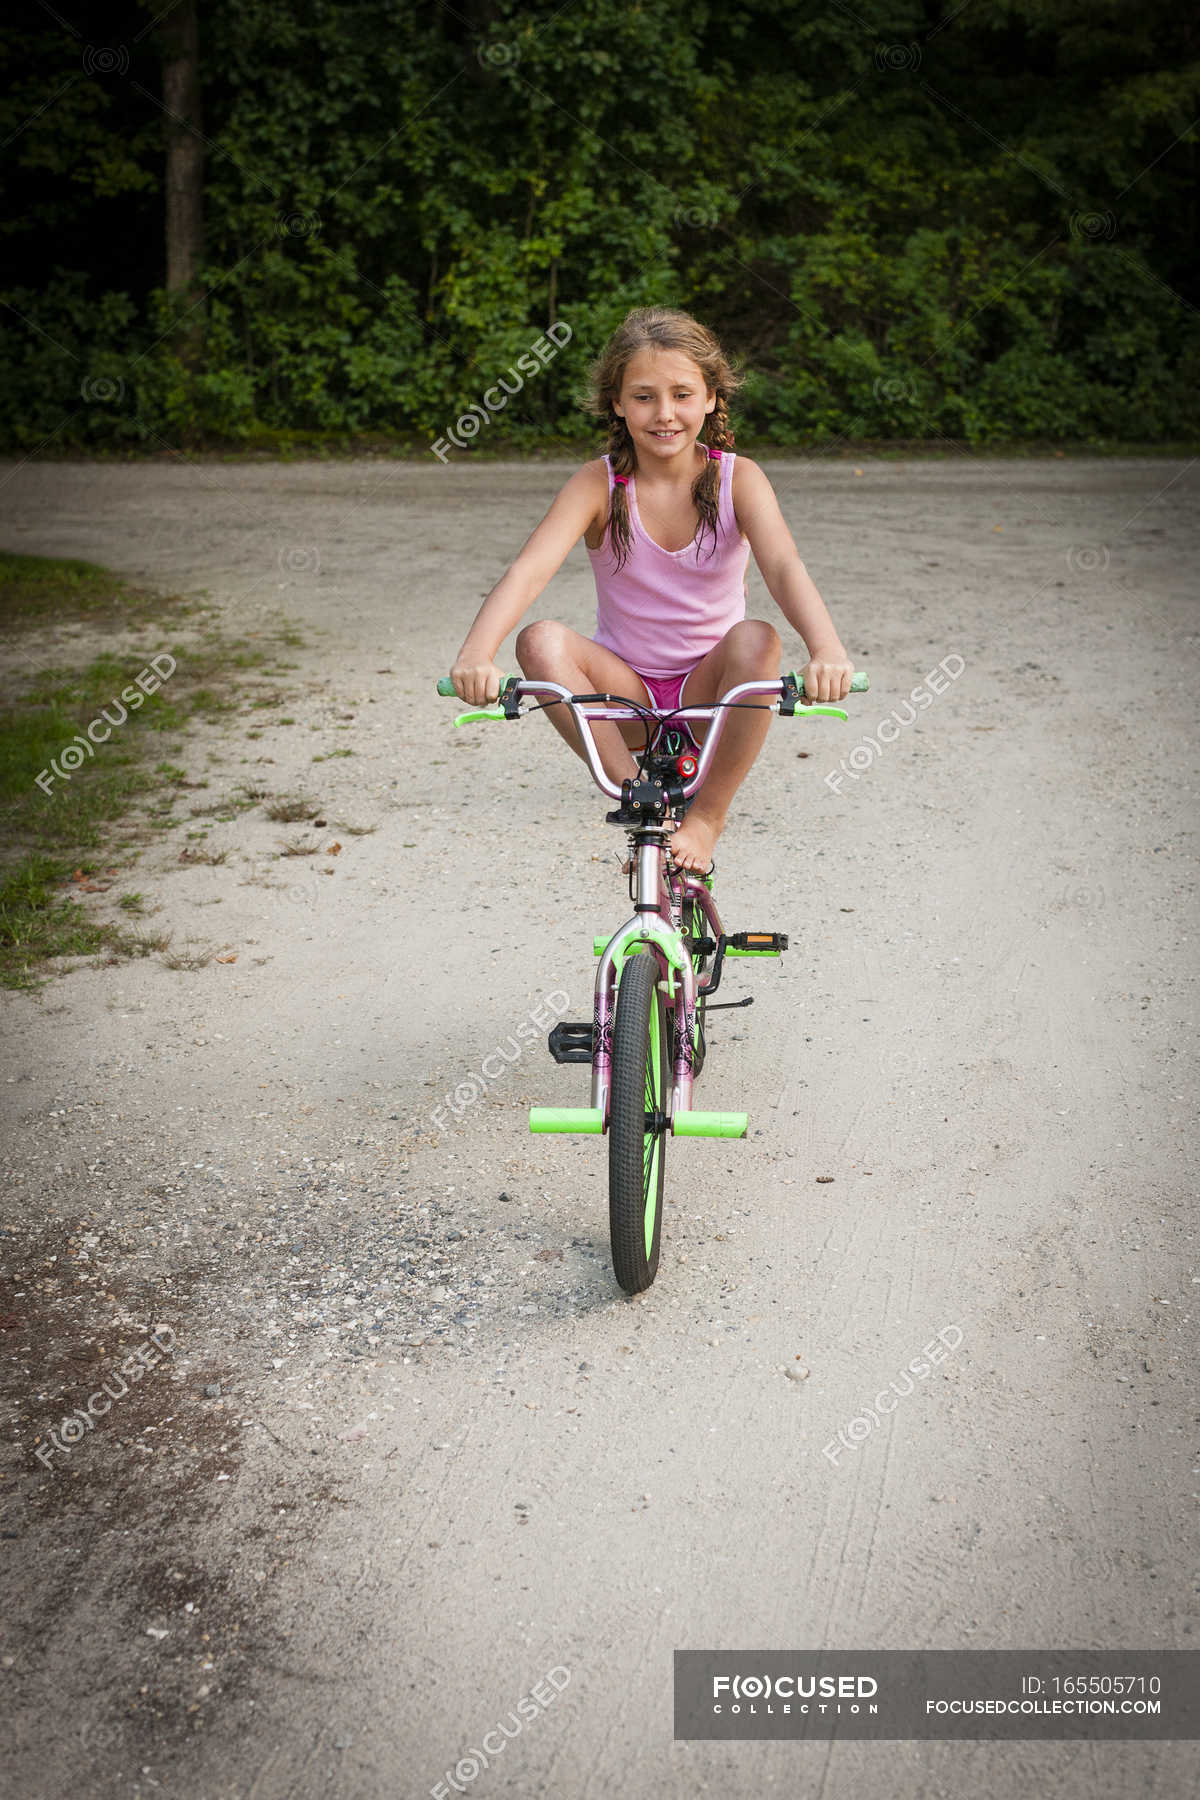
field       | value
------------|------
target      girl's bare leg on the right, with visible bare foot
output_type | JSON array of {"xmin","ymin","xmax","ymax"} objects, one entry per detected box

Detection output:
[{"xmin": 671, "ymin": 619, "xmax": 783, "ymax": 875}]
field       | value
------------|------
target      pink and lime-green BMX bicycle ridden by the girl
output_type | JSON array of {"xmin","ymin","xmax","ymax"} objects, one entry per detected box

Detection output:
[{"xmin": 437, "ymin": 671, "xmax": 869, "ymax": 1294}]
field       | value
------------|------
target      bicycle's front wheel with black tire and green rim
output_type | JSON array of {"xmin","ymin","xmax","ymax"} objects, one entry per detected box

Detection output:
[{"xmin": 608, "ymin": 950, "xmax": 671, "ymax": 1294}]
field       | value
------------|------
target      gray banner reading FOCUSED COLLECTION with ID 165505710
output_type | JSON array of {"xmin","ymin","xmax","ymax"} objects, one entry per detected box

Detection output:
[{"xmin": 675, "ymin": 1651, "xmax": 1200, "ymax": 1739}]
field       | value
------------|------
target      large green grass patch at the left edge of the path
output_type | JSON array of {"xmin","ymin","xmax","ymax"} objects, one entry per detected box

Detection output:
[{"xmin": 0, "ymin": 553, "xmax": 305, "ymax": 988}]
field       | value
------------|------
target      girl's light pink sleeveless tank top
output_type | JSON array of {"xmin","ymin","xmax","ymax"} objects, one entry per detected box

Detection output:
[{"xmin": 588, "ymin": 450, "xmax": 750, "ymax": 677}]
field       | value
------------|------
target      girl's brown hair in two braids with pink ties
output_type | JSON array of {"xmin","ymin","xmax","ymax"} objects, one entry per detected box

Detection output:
[{"xmin": 587, "ymin": 306, "xmax": 743, "ymax": 567}]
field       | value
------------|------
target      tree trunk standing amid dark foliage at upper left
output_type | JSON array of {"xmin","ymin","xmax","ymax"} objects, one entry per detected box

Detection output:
[{"xmin": 158, "ymin": 0, "xmax": 205, "ymax": 356}]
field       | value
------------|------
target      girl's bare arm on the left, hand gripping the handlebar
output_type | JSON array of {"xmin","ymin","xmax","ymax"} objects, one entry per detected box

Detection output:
[{"xmin": 450, "ymin": 463, "xmax": 608, "ymax": 706}]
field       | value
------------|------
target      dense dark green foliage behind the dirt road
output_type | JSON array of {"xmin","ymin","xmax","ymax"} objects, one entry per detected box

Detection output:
[{"xmin": 0, "ymin": 0, "xmax": 1200, "ymax": 448}]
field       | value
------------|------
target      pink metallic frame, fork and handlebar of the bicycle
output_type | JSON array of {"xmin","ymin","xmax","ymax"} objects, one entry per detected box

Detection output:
[{"xmin": 516, "ymin": 675, "xmax": 781, "ymax": 1129}]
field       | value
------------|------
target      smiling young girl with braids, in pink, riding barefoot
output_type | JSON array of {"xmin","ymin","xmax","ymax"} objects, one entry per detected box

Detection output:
[{"xmin": 450, "ymin": 306, "xmax": 853, "ymax": 873}]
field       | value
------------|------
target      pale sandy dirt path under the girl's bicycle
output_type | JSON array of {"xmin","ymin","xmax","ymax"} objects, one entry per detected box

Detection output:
[{"xmin": 0, "ymin": 459, "xmax": 1200, "ymax": 1800}]
